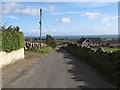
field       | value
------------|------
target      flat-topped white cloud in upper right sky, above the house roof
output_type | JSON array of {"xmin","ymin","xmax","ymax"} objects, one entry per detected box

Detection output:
[{"xmin": 81, "ymin": 12, "xmax": 101, "ymax": 19}]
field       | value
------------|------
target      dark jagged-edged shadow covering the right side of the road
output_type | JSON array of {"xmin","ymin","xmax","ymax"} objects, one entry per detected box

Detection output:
[{"xmin": 57, "ymin": 48, "xmax": 113, "ymax": 88}]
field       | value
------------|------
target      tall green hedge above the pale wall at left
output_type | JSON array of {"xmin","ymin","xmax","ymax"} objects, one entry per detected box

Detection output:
[{"xmin": 0, "ymin": 26, "xmax": 25, "ymax": 52}]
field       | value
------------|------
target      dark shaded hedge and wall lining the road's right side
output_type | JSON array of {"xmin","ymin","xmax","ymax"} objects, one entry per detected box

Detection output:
[{"xmin": 66, "ymin": 44, "xmax": 120, "ymax": 88}]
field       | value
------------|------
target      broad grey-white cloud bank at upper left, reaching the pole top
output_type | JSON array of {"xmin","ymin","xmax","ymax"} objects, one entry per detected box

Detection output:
[{"xmin": 2, "ymin": 2, "xmax": 42, "ymax": 15}]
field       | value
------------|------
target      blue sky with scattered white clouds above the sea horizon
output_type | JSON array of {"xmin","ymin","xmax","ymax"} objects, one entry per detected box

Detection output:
[{"xmin": 2, "ymin": 2, "xmax": 118, "ymax": 36}]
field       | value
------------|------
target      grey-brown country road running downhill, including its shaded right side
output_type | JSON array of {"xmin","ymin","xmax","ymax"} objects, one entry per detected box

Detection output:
[{"xmin": 3, "ymin": 50, "xmax": 113, "ymax": 88}]
